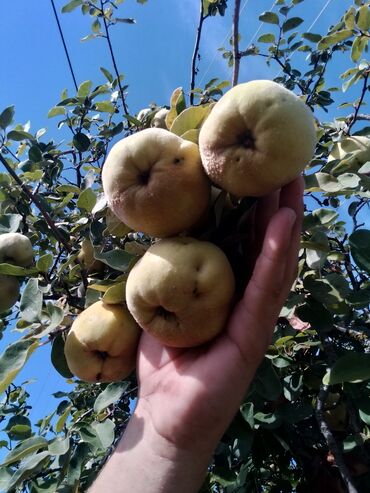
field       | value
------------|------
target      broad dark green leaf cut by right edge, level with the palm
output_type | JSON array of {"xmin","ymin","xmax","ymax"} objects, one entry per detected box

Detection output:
[{"xmin": 323, "ymin": 352, "xmax": 370, "ymax": 385}]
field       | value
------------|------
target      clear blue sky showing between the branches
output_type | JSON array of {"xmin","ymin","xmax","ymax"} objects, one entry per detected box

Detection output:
[{"xmin": 0, "ymin": 0, "xmax": 360, "ymax": 420}]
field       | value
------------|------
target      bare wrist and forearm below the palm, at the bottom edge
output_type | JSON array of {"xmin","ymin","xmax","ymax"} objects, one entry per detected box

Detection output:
[{"xmin": 89, "ymin": 401, "xmax": 213, "ymax": 493}]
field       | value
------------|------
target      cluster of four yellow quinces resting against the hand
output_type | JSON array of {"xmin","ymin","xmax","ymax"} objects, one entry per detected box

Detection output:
[{"xmin": 65, "ymin": 81, "xmax": 316, "ymax": 381}]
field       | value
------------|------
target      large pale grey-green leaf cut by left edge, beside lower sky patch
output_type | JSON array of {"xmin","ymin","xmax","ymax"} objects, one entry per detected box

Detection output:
[{"xmin": 0, "ymin": 339, "xmax": 39, "ymax": 394}]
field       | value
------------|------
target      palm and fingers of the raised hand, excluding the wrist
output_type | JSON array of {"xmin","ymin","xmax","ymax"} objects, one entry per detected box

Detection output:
[{"xmin": 137, "ymin": 178, "xmax": 303, "ymax": 450}]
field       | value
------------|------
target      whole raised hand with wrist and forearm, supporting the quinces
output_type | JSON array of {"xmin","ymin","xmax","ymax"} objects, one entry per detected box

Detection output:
[{"xmin": 91, "ymin": 178, "xmax": 303, "ymax": 493}]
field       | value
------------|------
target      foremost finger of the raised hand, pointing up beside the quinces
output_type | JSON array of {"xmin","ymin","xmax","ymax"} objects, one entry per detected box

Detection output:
[{"xmin": 228, "ymin": 208, "xmax": 296, "ymax": 362}]
